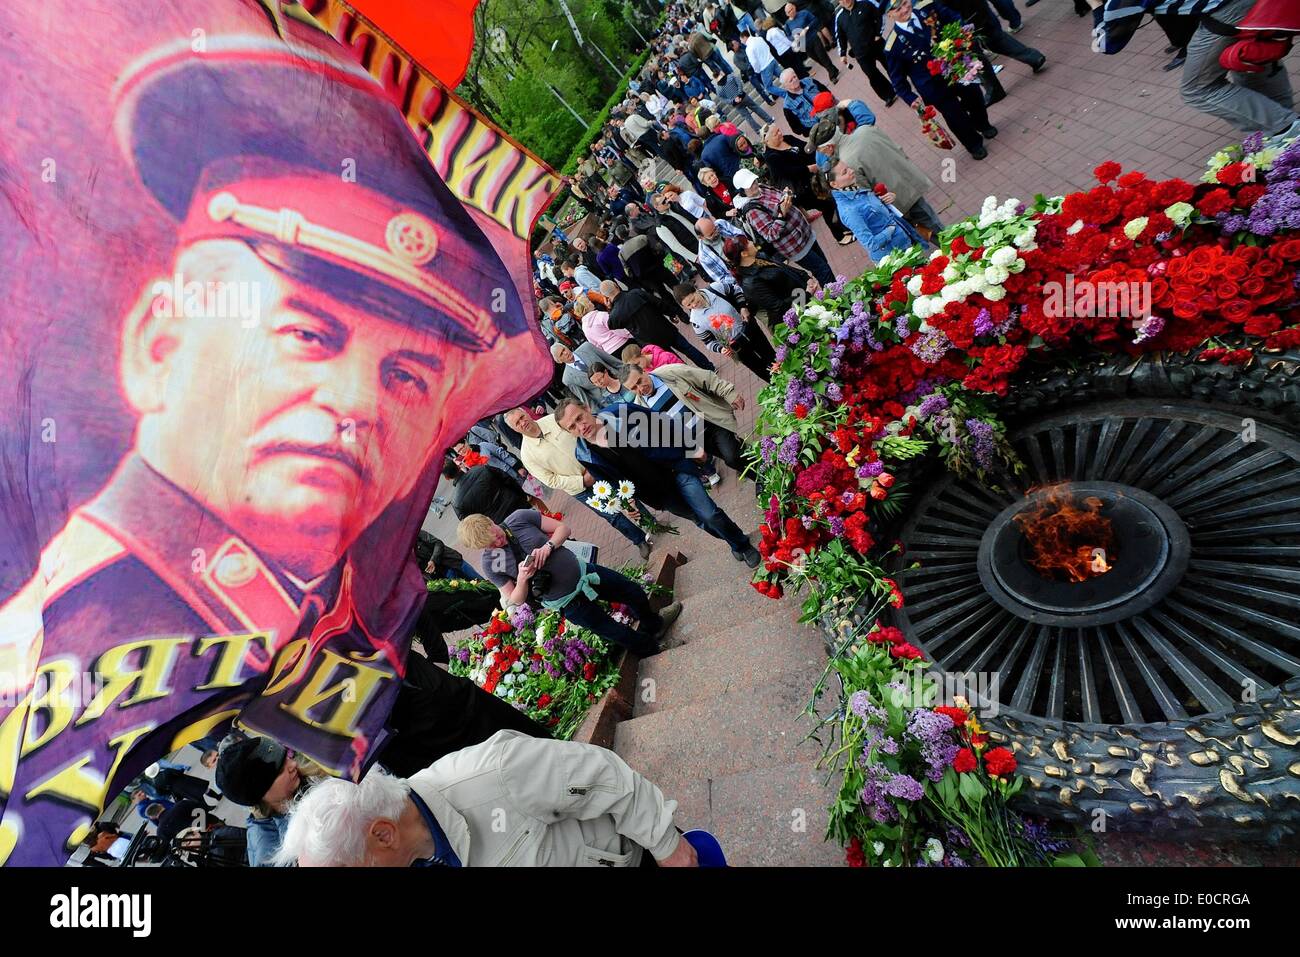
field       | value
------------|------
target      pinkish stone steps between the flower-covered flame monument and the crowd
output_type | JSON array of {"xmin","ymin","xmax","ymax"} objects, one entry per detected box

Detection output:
[{"xmin": 614, "ymin": 473, "xmax": 844, "ymax": 866}]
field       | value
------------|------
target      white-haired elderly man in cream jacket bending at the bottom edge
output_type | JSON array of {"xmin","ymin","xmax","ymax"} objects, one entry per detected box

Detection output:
[{"xmin": 274, "ymin": 731, "xmax": 698, "ymax": 867}]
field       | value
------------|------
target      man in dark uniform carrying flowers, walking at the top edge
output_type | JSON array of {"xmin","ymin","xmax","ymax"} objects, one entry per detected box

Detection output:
[{"xmin": 885, "ymin": 0, "xmax": 997, "ymax": 160}]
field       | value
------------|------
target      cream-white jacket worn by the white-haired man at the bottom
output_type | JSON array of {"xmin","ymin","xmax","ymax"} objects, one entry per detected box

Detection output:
[{"xmin": 407, "ymin": 731, "xmax": 681, "ymax": 867}]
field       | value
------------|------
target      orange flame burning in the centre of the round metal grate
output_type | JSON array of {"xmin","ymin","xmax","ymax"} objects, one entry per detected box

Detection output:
[{"xmin": 1011, "ymin": 482, "xmax": 1115, "ymax": 581}]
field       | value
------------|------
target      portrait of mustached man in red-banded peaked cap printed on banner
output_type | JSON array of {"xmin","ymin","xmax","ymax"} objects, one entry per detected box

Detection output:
[{"xmin": 0, "ymin": 26, "xmax": 545, "ymax": 863}]
